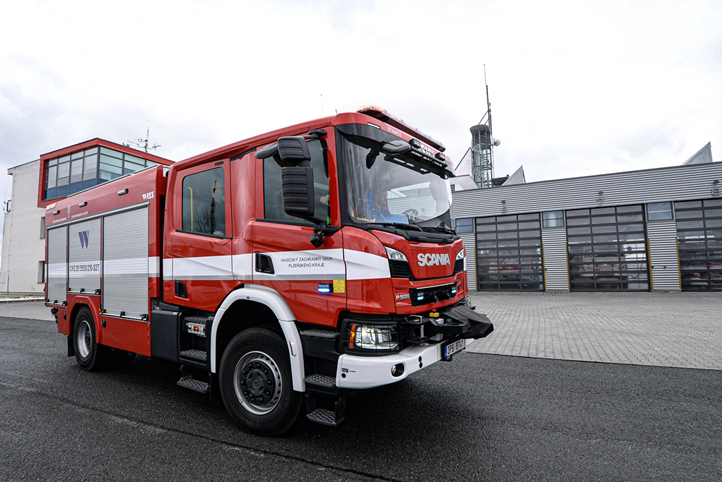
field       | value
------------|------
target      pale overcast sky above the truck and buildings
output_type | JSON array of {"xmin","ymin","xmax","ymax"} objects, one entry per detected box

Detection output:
[{"xmin": 0, "ymin": 0, "xmax": 722, "ymax": 241}]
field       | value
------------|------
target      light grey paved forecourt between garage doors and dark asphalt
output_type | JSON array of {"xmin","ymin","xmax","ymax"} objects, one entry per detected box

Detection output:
[{"xmin": 469, "ymin": 292, "xmax": 722, "ymax": 370}]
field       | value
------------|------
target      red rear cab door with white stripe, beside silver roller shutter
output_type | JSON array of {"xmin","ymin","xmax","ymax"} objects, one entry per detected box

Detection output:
[{"xmin": 164, "ymin": 160, "xmax": 235, "ymax": 311}]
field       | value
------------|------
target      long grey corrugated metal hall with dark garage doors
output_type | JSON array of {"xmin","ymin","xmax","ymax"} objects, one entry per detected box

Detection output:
[{"xmin": 452, "ymin": 144, "xmax": 722, "ymax": 292}]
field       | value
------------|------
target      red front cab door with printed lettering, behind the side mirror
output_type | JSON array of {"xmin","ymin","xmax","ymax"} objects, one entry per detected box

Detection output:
[{"xmin": 253, "ymin": 140, "xmax": 346, "ymax": 326}]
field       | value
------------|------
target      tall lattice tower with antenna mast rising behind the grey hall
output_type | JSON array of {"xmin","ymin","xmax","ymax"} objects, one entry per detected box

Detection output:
[{"xmin": 456, "ymin": 64, "xmax": 501, "ymax": 189}]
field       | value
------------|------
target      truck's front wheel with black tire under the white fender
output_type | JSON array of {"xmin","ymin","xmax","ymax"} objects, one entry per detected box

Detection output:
[{"xmin": 220, "ymin": 328, "xmax": 303, "ymax": 436}]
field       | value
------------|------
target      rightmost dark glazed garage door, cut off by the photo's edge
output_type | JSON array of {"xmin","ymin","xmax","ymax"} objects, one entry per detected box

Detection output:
[{"xmin": 674, "ymin": 199, "xmax": 722, "ymax": 291}]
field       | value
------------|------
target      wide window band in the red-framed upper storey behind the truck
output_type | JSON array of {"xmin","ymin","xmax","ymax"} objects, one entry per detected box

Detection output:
[{"xmin": 44, "ymin": 147, "xmax": 158, "ymax": 199}]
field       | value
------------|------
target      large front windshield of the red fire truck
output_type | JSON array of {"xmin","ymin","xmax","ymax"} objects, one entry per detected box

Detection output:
[{"xmin": 338, "ymin": 129, "xmax": 451, "ymax": 231}]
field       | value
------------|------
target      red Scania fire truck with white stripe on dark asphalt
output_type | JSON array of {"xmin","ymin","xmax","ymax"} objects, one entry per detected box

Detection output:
[{"xmin": 46, "ymin": 106, "xmax": 493, "ymax": 435}]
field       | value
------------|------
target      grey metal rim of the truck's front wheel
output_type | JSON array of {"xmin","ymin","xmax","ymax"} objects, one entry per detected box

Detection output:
[{"xmin": 233, "ymin": 351, "xmax": 282, "ymax": 415}]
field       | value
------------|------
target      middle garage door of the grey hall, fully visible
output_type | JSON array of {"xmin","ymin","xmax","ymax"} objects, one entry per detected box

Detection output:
[{"xmin": 566, "ymin": 205, "xmax": 649, "ymax": 291}]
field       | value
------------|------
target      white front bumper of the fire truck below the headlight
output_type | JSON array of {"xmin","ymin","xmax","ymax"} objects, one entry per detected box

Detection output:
[{"xmin": 336, "ymin": 340, "xmax": 474, "ymax": 389}]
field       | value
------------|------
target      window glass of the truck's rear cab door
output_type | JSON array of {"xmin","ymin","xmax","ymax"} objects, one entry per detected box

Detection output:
[{"xmin": 183, "ymin": 167, "xmax": 226, "ymax": 236}]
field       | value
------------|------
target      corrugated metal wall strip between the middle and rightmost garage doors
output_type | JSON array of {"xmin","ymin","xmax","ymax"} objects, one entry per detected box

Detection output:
[{"xmin": 647, "ymin": 221, "xmax": 680, "ymax": 291}]
